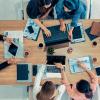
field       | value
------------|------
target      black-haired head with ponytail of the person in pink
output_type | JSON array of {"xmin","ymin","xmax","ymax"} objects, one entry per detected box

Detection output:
[{"xmin": 76, "ymin": 80, "xmax": 93, "ymax": 98}]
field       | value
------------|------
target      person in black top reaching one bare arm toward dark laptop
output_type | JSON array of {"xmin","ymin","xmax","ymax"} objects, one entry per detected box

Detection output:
[{"xmin": 26, "ymin": 0, "xmax": 58, "ymax": 37}]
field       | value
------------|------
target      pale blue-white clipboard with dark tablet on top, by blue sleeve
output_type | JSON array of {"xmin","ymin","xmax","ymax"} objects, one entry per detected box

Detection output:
[{"xmin": 67, "ymin": 23, "xmax": 85, "ymax": 43}]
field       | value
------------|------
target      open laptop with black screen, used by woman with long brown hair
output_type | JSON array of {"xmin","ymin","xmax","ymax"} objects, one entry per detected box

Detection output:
[{"xmin": 46, "ymin": 55, "xmax": 66, "ymax": 78}]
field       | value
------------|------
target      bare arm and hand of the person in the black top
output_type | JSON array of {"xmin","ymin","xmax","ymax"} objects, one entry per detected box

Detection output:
[{"xmin": 33, "ymin": 19, "xmax": 51, "ymax": 37}]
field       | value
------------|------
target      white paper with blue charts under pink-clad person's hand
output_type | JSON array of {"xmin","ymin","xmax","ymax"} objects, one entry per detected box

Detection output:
[{"xmin": 69, "ymin": 56, "xmax": 93, "ymax": 73}]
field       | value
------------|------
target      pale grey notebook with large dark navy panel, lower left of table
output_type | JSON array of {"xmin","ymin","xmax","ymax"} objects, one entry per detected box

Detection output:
[{"xmin": 17, "ymin": 63, "xmax": 32, "ymax": 82}]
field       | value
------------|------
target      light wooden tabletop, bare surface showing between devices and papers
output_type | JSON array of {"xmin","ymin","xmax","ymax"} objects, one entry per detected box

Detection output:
[{"xmin": 0, "ymin": 20, "xmax": 100, "ymax": 85}]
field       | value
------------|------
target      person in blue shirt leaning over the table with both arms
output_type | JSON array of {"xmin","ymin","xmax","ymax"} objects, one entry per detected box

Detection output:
[{"xmin": 55, "ymin": 0, "xmax": 87, "ymax": 38}]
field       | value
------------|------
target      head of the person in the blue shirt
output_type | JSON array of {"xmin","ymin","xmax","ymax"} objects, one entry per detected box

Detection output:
[{"xmin": 64, "ymin": 0, "xmax": 76, "ymax": 12}]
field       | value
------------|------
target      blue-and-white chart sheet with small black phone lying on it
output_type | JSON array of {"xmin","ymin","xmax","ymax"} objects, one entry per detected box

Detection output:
[{"xmin": 24, "ymin": 18, "xmax": 40, "ymax": 40}]
